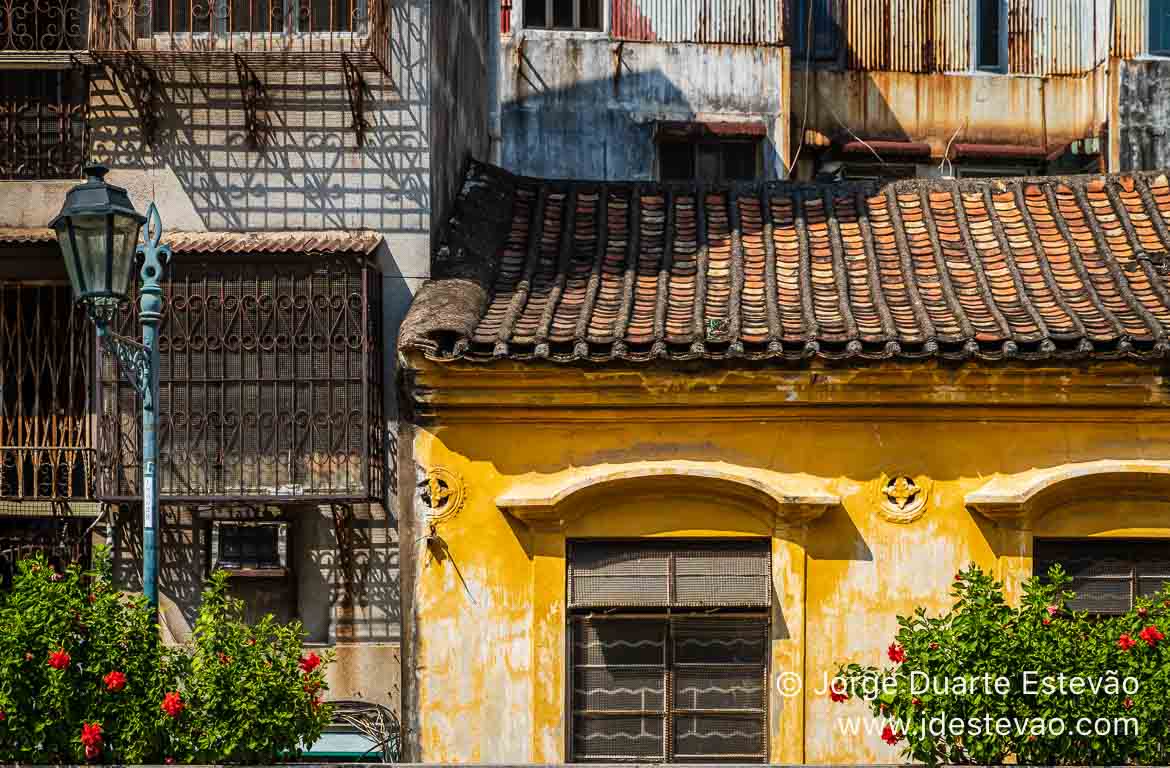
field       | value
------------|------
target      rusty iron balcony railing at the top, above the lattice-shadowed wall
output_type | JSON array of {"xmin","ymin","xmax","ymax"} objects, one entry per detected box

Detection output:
[{"xmin": 88, "ymin": 0, "xmax": 390, "ymax": 64}]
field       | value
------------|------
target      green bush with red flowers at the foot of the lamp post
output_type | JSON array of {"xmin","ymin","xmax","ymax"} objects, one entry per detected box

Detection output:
[{"xmin": 0, "ymin": 554, "xmax": 330, "ymax": 763}]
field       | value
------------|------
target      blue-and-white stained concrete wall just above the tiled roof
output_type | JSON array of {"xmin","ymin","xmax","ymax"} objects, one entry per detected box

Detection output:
[{"xmin": 500, "ymin": 29, "xmax": 787, "ymax": 180}]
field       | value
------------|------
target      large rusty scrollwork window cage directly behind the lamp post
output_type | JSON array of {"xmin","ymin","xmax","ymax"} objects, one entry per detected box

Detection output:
[{"xmin": 99, "ymin": 255, "xmax": 385, "ymax": 501}]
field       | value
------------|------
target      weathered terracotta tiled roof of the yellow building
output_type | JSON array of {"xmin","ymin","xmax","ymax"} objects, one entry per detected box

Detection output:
[{"xmin": 400, "ymin": 164, "xmax": 1170, "ymax": 362}]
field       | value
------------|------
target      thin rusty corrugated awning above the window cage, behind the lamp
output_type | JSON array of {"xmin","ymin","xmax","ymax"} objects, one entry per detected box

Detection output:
[{"xmin": 0, "ymin": 227, "xmax": 381, "ymax": 254}]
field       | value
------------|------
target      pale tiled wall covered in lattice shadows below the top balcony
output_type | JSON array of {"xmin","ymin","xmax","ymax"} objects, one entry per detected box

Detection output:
[{"xmin": 90, "ymin": 0, "xmax": 432, "ymax": 234}]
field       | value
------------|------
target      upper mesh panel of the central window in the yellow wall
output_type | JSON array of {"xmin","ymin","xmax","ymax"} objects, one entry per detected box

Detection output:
[{"xmin": 569, "ymin": 541, "xmax": 771, "ymax": 608}]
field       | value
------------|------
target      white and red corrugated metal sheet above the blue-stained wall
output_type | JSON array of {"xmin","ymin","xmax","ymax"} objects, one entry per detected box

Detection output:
[{"xmin": 610, "ymin": 0, "xmax": 784, "ymax": 46}]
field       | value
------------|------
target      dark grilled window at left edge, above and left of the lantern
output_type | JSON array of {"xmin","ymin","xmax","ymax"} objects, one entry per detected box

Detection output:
[{"xmin": 0, "ymin": 69, "xmax": 89, "ymax": 179}]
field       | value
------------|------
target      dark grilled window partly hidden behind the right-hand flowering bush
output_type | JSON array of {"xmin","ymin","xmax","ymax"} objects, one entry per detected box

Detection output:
[{"xmin": 1032, "ymin": 539, "xmax": 1170, "ymax": 613}]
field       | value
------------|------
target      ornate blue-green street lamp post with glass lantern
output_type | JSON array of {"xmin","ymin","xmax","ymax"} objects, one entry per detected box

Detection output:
[{"xmin": 49, "ymin": 165, "xmax": 171, "ymax": 605}]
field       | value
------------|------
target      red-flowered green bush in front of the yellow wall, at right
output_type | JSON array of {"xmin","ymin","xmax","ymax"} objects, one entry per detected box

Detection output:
[{"xmin": 828, "ymin": 565, "xmax": 1170, "ymax": 764}]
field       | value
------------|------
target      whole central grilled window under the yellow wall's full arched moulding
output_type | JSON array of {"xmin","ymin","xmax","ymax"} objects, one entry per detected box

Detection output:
[{"xmin": 569, "ymin": 540, "xmax": 771, "ymax": 762}]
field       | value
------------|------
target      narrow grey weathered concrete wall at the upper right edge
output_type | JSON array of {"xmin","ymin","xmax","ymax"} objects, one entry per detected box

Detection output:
[{"xmin": 1117, "ymin": 59, "xmax": 1170, "ymax": 171}]
